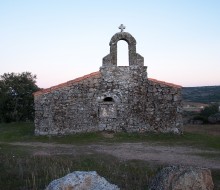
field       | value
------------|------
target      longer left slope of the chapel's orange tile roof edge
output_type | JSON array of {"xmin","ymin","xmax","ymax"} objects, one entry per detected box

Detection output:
[{"xmin": 33, "ymin": 71, "xmax": 100, "ymax": 96}]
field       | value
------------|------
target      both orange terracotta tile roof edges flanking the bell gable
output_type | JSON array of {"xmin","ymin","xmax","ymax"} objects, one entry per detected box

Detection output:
[{"xmin": 33, "ymin": 71, "xmax": 182, "ymax": 96}]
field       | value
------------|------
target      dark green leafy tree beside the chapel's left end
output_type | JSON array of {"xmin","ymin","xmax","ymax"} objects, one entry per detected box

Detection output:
[{"xmin": 0, "ymin": 72, "xmax": 39, "ymax": 122}]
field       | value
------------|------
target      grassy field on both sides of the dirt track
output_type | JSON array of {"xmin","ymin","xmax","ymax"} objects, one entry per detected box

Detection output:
[{"xmin": 0, "ymin": 123, "xmax": 220, "ymax": 190}]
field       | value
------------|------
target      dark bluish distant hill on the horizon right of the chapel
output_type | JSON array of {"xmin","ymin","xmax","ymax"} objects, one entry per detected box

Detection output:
[{"xmin": 182, "ymin": 86, "xmax": 220, "ymax": 103}]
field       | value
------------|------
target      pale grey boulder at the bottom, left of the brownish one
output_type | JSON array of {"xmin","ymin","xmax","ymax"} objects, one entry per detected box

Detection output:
[{"xmin": 46, "ymin": 171, "xmax": 119, "ymax": 190}]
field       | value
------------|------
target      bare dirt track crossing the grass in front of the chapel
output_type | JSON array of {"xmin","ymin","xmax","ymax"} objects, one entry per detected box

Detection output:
[{"xmin": 10, "ymin": 142, "xmax": 220, "ymax": 169}]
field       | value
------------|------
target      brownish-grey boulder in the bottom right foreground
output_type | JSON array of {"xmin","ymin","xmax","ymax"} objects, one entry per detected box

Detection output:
[{"xmin": 149, "ymin": 166, "xmax": 214, "ymax": 190}]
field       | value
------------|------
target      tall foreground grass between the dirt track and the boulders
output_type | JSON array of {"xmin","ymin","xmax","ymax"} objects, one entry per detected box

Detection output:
[{"xmin": 0, "ymin": 145, "xmax": 160, "ymax": 190}]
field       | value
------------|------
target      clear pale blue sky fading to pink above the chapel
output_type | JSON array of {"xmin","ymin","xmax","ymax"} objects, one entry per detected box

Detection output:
[{"xmin": 0, "ymin": 0, "xmax": 220, "ymax": 88}]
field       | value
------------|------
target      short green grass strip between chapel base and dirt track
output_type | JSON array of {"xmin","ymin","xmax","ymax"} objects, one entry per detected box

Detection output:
[{"xmin": 0, "ymin": 123, "xmax": 220, "ymax": 150}]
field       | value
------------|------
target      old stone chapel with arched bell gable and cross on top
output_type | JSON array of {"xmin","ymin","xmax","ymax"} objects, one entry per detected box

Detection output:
[{"xmin": 34, "ymin": 25, "xmax": 183, "ymax": 135}]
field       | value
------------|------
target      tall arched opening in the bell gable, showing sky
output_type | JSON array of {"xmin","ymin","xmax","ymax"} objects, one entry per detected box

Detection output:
[{"xmin": 117, "ymin": 40, "xmax": 129, "ymax": 66}]
